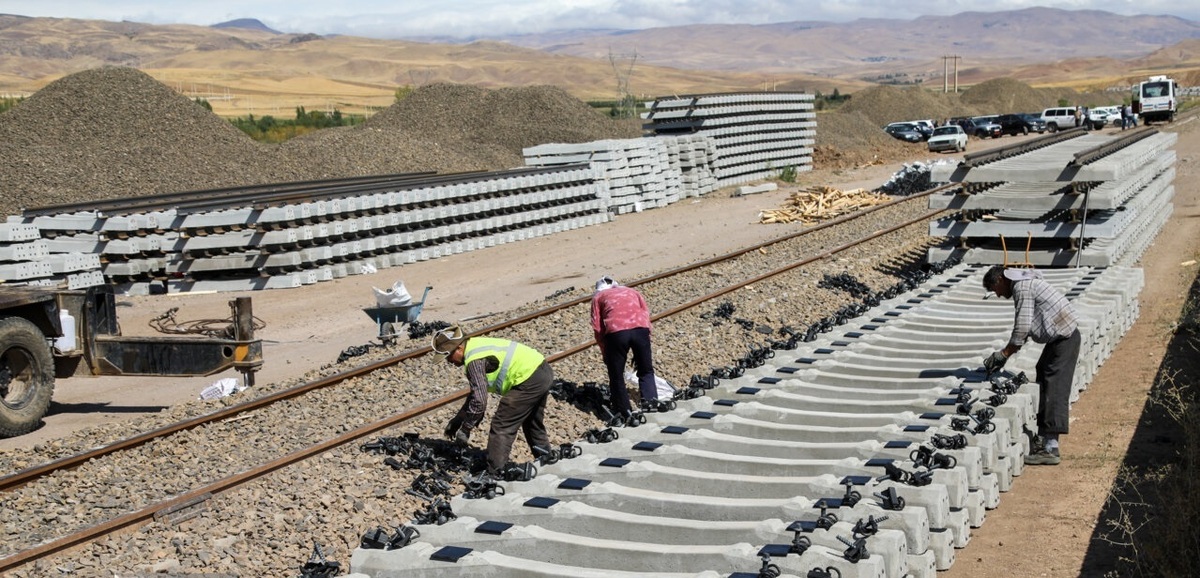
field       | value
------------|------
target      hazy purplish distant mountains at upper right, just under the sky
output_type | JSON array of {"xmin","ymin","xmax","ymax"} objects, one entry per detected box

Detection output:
[{"xmin": 503, "ymin": 7, "xmax": 1200, "ymax": 84}]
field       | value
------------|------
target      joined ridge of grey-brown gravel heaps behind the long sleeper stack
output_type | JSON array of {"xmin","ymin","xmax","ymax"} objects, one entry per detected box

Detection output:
[{"xmin": 0, "ymin": 66, "xmax": 641, "ymax": 215}]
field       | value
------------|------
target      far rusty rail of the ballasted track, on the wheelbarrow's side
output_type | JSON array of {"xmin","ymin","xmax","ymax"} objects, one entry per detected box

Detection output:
[{"xmin": 0, "ymin": 185, "xmax": 955, "ymax": 492}]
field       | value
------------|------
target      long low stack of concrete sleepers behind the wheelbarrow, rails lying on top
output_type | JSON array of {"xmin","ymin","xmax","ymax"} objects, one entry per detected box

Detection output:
[{"xmin": 26, "ymin": 164, "xmax": 608, "ymax": 293}]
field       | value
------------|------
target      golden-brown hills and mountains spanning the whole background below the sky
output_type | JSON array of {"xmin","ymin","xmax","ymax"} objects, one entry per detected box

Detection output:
[{"xmin": 0, "ymin": 7, "xmax": 1200, "ymax": 114}]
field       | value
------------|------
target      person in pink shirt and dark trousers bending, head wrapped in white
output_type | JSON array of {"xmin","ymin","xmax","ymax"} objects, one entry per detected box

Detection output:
[{"xmin": 592, "ymin": 276, "xmax": 659, "ymax": 422}]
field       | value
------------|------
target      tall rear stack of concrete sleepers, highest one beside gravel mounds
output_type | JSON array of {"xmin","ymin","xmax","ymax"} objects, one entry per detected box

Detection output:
[{"xmin": 642, "ymin": 92, "xmax": 817, "ymax": 187}]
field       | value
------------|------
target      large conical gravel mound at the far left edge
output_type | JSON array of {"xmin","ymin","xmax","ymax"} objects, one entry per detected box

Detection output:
[{"xmin": 0, "ymin": 67, "xmax": 262, "ymax": 215}]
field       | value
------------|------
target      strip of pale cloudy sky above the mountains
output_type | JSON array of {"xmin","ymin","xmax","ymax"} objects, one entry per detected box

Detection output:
[{"xmin": 0, "ymin": 0, "xmax": 1200, "ymax": 38}]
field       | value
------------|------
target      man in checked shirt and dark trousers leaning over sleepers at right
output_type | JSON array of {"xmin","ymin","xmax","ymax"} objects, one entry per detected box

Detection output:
[{"xmin": 983, "ymin": 265, "xmax": 1081, "ymax": 465}]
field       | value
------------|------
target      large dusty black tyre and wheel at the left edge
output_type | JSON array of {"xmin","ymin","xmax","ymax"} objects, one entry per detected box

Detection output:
[{"xmin": 0, "ymin": 317, "xmax": 54, "ymax": 438}]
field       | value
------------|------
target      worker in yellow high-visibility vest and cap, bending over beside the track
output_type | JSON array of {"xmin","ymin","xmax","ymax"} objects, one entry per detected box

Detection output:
[{"xmin": 433, "ymin": 326, "xmax": 554, "ymax": 480}]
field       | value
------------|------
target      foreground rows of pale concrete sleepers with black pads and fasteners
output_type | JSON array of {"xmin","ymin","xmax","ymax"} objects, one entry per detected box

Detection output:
[{"xmin": 350, "ymin": 266, "xmax": 1141, "ymax": 578}]
